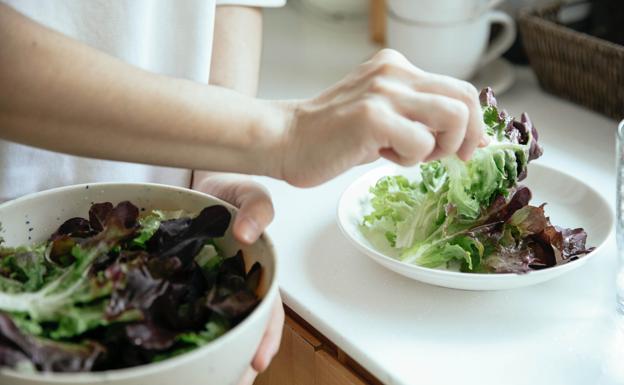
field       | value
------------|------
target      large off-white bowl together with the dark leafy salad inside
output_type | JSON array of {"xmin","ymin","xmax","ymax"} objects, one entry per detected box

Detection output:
[{"xmin": 0, "ymin": 183, "xmax": 277, "ymax": 385}]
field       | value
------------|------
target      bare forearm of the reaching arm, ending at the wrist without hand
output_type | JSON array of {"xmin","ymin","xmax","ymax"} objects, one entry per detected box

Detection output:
[{"xmin": 0, "ymin": 5, "xmax": 286, "ymax": 175}]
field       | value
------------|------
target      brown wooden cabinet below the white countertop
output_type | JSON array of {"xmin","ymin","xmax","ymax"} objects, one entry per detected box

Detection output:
[{"xmin": 254, "ymin": 309, "xmax": 381, "ymax": 385}]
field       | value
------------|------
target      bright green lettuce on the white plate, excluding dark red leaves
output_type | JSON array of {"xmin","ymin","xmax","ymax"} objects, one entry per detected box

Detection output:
[{"xmin": 361, "ymin": 90, "xmax": 542, "ymax": 272}]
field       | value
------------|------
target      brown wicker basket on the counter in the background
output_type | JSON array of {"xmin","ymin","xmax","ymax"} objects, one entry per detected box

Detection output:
[{"xmin": 519, "ymin": 4, "xmax": 624, "ymax": 120}]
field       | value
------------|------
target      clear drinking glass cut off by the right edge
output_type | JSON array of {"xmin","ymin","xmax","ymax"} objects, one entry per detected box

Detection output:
[{"xmin": 615, "ymin": 120, "xmax": 624, "ymax": 314}]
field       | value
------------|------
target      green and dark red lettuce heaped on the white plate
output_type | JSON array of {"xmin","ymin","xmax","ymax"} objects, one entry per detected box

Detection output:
[{"xmin": 361, "ymin": 88, "xmax": 592, "ymax": 273}]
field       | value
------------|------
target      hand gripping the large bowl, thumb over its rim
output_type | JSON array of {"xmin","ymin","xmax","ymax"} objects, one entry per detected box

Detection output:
[{"xmin": 193, "ymin": 173, "xmax": 284, "ymax": 385}]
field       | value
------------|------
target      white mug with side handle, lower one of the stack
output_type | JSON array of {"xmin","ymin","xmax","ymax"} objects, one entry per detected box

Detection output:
[{"xmin": 386, "ymin": 10, "xmax": 516, "ymax": 79}]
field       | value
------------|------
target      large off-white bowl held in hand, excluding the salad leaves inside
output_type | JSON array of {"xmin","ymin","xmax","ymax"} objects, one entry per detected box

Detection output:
[{"xmin": 0, "ymin": 183, "xmax": 278, "ymax": 385}]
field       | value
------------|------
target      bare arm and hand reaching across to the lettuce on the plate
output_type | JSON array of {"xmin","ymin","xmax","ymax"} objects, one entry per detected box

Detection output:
[{"xmin": 0, "ymin": 5, "xmax": 483, "ymax": 187}]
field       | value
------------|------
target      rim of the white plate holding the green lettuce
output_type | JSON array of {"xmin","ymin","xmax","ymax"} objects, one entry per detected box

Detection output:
[{"xmin": 336, "ymin": 162, "xmax": 615, "ymax": 281}]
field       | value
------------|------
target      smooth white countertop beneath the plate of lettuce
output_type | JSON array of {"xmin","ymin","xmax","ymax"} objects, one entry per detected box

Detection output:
[{"xmin": 258, "ymin": 3, "xmax": 624, "ymax": 385}]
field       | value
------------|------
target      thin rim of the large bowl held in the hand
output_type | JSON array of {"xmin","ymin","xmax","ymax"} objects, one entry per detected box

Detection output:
[{"xmin": 0, "ymin": 182, "xmax": 279, "ymax": 384}]
